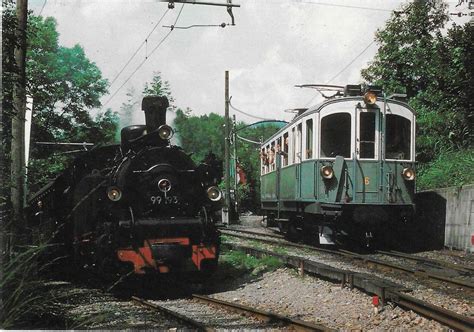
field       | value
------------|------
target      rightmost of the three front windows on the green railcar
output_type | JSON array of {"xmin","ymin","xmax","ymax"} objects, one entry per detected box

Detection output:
[{"xmin": 385, "ymin": 114, "xmax": 411, "ymax": 160}]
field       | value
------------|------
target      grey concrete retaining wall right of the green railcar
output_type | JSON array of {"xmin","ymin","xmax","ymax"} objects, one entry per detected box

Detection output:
[{"xmin": 417, "ymin": 185, "xmax": 474, "ymax": 252}]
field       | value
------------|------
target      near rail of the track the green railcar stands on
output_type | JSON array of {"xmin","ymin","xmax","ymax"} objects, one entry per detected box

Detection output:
[{"xmin": 221, "ymin": 229, "xmax": 474, "ymax": 290}]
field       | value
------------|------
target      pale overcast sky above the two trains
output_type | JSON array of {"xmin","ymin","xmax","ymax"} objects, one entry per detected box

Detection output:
[{"xmin": 29, "ymin": 0, "xmax": 468, "ymax": 123}]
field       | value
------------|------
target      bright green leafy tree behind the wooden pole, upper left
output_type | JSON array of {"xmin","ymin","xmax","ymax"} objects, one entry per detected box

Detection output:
[{"xmin": 2, "ymin": 7, "xmax": 118, "ymax": 189}]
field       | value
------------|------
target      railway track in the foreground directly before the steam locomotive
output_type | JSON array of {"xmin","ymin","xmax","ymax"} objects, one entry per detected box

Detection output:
[{"xmin": 132, "ymin": 295, "xmax": 330, "ymax": 331}]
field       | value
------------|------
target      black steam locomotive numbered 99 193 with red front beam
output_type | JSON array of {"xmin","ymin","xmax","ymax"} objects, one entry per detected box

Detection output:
[{"xmin": 29, "ymin": 96, "xmax": 222, "ymax": 275}]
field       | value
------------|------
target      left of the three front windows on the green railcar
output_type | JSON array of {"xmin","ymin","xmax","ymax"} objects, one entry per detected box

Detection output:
[{"xmin": 321, "ymin": 113, "xmax": 351, "ymax": 158}]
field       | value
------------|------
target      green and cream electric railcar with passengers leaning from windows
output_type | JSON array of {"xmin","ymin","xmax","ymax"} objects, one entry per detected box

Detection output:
[{"xmin": 261, "ymin": 86, "xmax": 415, "ymax": 243}]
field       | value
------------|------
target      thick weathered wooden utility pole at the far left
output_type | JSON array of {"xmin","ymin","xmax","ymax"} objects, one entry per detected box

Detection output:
[{"xmin": 10, "ymin": 0, "xmax": 28, "ymax": 250}]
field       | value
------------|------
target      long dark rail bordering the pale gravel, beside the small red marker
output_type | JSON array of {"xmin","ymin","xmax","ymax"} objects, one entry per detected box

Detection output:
[{"xmin": 225, "ymin": 244, "xmax": 474, "ymax": 331}]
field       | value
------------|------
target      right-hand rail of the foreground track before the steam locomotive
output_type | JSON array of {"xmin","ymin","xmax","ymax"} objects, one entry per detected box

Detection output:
[{"xmin": 192, "ymin": 294, "xmax": 333, "ymax": 331}]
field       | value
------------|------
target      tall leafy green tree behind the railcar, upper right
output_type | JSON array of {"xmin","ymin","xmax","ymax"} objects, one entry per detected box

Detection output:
[{"xmin": 362, "ymin": 1, "xmax": 474, "ymax": 167}]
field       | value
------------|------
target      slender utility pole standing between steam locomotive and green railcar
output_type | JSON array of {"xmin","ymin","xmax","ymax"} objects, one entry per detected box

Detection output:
[{"xmin": 222, "ymin": 70, "xmax": 230, "ymax": 225}]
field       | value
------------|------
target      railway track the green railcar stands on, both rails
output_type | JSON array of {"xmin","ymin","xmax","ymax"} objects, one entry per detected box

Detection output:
[{"xmin": 221, "ymin": 229, "xmax": 474, "ymax": 291}]
